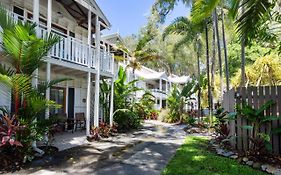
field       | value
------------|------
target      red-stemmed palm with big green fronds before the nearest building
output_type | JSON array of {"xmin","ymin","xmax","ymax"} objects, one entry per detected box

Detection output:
[{"xmin": 0, "ymin": 8, "xmax": 60, "ymax": 113}]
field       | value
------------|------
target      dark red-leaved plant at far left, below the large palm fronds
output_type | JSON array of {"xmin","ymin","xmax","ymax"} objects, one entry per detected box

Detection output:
[{"xmin": 0, "ymin": 115, "xmax": 23, "ymax": 147}]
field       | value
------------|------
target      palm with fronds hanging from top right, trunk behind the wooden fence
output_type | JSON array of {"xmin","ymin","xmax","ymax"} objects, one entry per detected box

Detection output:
[{"xmin": 190, "ymin": 0, "xmax": 278, "ymax": 85}]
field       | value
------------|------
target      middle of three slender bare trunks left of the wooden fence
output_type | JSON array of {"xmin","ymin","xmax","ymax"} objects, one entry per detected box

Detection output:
[{"xmin": 213, "ymin": 8, "xmax": 223, "ymax": 99}]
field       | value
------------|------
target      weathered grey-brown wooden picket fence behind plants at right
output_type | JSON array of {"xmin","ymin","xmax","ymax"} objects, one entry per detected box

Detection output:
[{"xmin": 222, "ymin": 86, "xmax": 281, "ymax": 154}]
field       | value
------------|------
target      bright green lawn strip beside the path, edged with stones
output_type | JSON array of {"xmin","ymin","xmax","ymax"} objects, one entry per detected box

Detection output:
[{"xmin": 162, "ymin": 136, "xmax": 265, "ymax": 175}]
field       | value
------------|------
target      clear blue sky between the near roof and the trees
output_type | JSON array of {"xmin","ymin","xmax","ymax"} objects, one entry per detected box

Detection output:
[{"xmin": 97, "ymin": 0, "xmax": 188, "ymax": 37}]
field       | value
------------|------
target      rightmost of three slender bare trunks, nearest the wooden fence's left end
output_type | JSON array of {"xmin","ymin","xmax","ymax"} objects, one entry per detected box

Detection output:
[{"xmin": 221, "ymin": 8, "xmax": 229, "ymax": 91}]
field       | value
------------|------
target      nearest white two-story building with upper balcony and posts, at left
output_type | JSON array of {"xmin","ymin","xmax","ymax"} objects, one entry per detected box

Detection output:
[{"xmin": 0, "ymin": 0, "xmax": 114, "ymax": 135}]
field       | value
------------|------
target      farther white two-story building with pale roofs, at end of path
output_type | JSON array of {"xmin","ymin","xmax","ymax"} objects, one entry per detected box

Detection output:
[{"xmin": 102, "ymin": 33, "xmax": 196, "ymax": 110}]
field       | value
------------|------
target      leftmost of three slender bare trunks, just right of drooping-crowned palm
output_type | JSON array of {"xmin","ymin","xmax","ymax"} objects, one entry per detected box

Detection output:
[{"xmin": 205, "ymin": 24, "xmax": 213, "ymax": 116}]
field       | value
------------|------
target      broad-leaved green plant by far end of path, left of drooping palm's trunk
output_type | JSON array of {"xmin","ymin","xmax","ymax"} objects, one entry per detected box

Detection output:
[{"xmin": 166, "ymin": 80, "xmax": 198, "ymax": 122}]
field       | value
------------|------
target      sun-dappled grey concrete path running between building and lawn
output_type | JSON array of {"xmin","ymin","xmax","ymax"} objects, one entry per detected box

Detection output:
[{"xmin": 14, "ymin": 121, "xmax": 186, "ymax": 175}]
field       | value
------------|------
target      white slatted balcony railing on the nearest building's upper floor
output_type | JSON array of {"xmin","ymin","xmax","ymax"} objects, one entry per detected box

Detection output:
[{"xmin": 9, "ymin": 12, "xmax": 114, "ymax": 74}]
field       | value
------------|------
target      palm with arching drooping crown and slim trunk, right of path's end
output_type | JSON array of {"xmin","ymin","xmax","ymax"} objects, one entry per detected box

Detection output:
[{"xmin": 163, "ymin": 17, "xmax": 204, "ymax": 117}]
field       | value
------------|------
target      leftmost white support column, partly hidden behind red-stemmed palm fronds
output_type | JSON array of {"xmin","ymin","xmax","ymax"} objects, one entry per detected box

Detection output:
[{"xmin": 32, "ymin": 0, "xmax": 40, "ymax": 87}]
